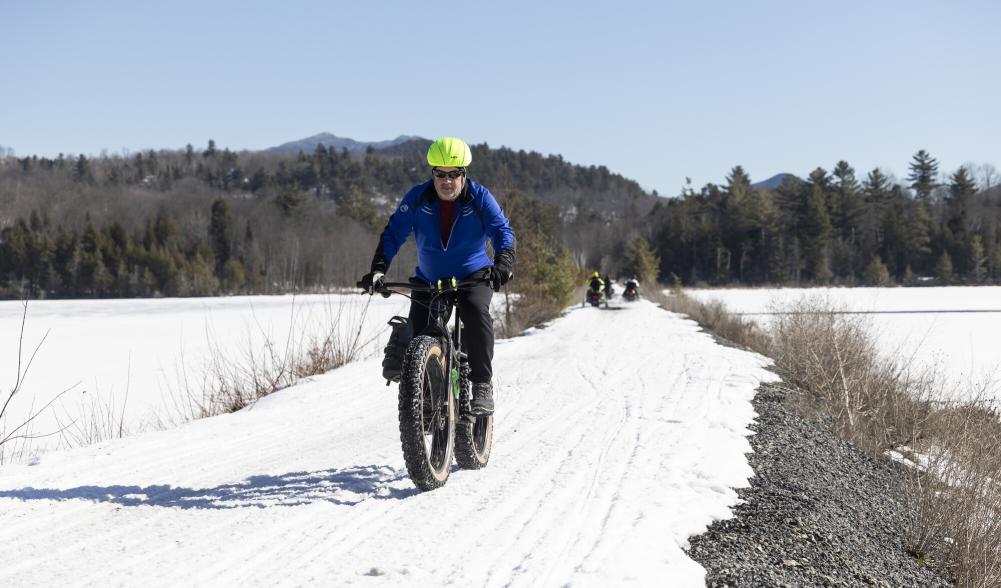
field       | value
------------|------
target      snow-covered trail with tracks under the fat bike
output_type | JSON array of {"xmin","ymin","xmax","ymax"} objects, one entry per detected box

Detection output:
[{"xmin": 0, "ymin": 301, "xmax": 775, "ymax": 586}]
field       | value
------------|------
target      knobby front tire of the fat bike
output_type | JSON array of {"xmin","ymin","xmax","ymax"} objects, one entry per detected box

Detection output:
[{"xmin": 399, "ymin": 335, "xmax": 455, "ymax": 491}]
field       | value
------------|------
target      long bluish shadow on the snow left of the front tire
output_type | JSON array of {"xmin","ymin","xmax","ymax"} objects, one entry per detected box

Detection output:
[{"xmin": 0, "ymin": 466, "xmax": 418, "ymax": 509}]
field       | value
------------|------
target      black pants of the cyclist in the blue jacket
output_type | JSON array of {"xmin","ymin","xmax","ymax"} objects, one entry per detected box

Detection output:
[{"xmin": 410, "ymin": 271, "xmax": 493, "ymax": 384}]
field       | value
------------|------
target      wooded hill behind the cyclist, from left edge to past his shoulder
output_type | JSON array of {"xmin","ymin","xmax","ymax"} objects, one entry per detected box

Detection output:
[{"xmin": 0, "ymin": 141, "xmax": 655, "ymax": 298}]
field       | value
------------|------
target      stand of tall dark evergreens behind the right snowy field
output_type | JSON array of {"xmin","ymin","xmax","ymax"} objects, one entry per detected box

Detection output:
[{"xmin": 650, "ymin": 150, "xmax": 1001, "ymax": 284}]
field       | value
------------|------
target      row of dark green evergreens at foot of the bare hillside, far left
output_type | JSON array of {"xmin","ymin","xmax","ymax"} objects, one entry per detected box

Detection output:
[{"xmin": 0, "ymin": 204, "xmax": 265, "ymax": 299}]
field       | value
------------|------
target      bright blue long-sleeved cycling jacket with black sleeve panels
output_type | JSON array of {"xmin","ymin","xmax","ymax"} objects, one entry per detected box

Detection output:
[{"xmin": 376, "ymin": 180, "xmax": 515, "ymax": 281}]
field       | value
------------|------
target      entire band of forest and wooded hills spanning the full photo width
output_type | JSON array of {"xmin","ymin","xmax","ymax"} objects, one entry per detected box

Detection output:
[{"xmin": 0, "ymin": 140, "xmax": 1001, "ymax": 298}]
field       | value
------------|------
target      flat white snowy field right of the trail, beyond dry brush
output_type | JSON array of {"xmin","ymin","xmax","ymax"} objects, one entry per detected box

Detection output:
[{"xmin": 686, "ymin": 286, "xmax": 1001, "ymax": 399}]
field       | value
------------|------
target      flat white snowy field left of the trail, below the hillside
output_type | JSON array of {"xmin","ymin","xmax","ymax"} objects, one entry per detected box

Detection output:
[{"xmin": 0, "ymin": 295, "xmax": 407, "ymax": 455}]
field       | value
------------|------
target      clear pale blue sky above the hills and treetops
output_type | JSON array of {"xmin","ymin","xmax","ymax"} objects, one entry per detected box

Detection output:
[{"xmin": 0, "ymin": 0, "xmax": 1001, "ymax": 194}]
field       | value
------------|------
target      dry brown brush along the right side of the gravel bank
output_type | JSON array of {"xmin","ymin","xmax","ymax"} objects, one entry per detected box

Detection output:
[{"xmin": 651, "ymin": 291, "xmax": 1001, "ymax": 587}]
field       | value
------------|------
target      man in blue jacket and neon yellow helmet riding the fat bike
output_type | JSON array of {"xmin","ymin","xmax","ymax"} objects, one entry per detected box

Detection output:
[{"xmin": 361, "ymin": 137, "xmax": 515, "ymax": 415}]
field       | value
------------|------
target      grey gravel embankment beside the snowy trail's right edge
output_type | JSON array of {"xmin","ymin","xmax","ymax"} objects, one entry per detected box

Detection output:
[{"xmin": 690, "ymin": 378, "xmax": 949, "ymax": 587}]
